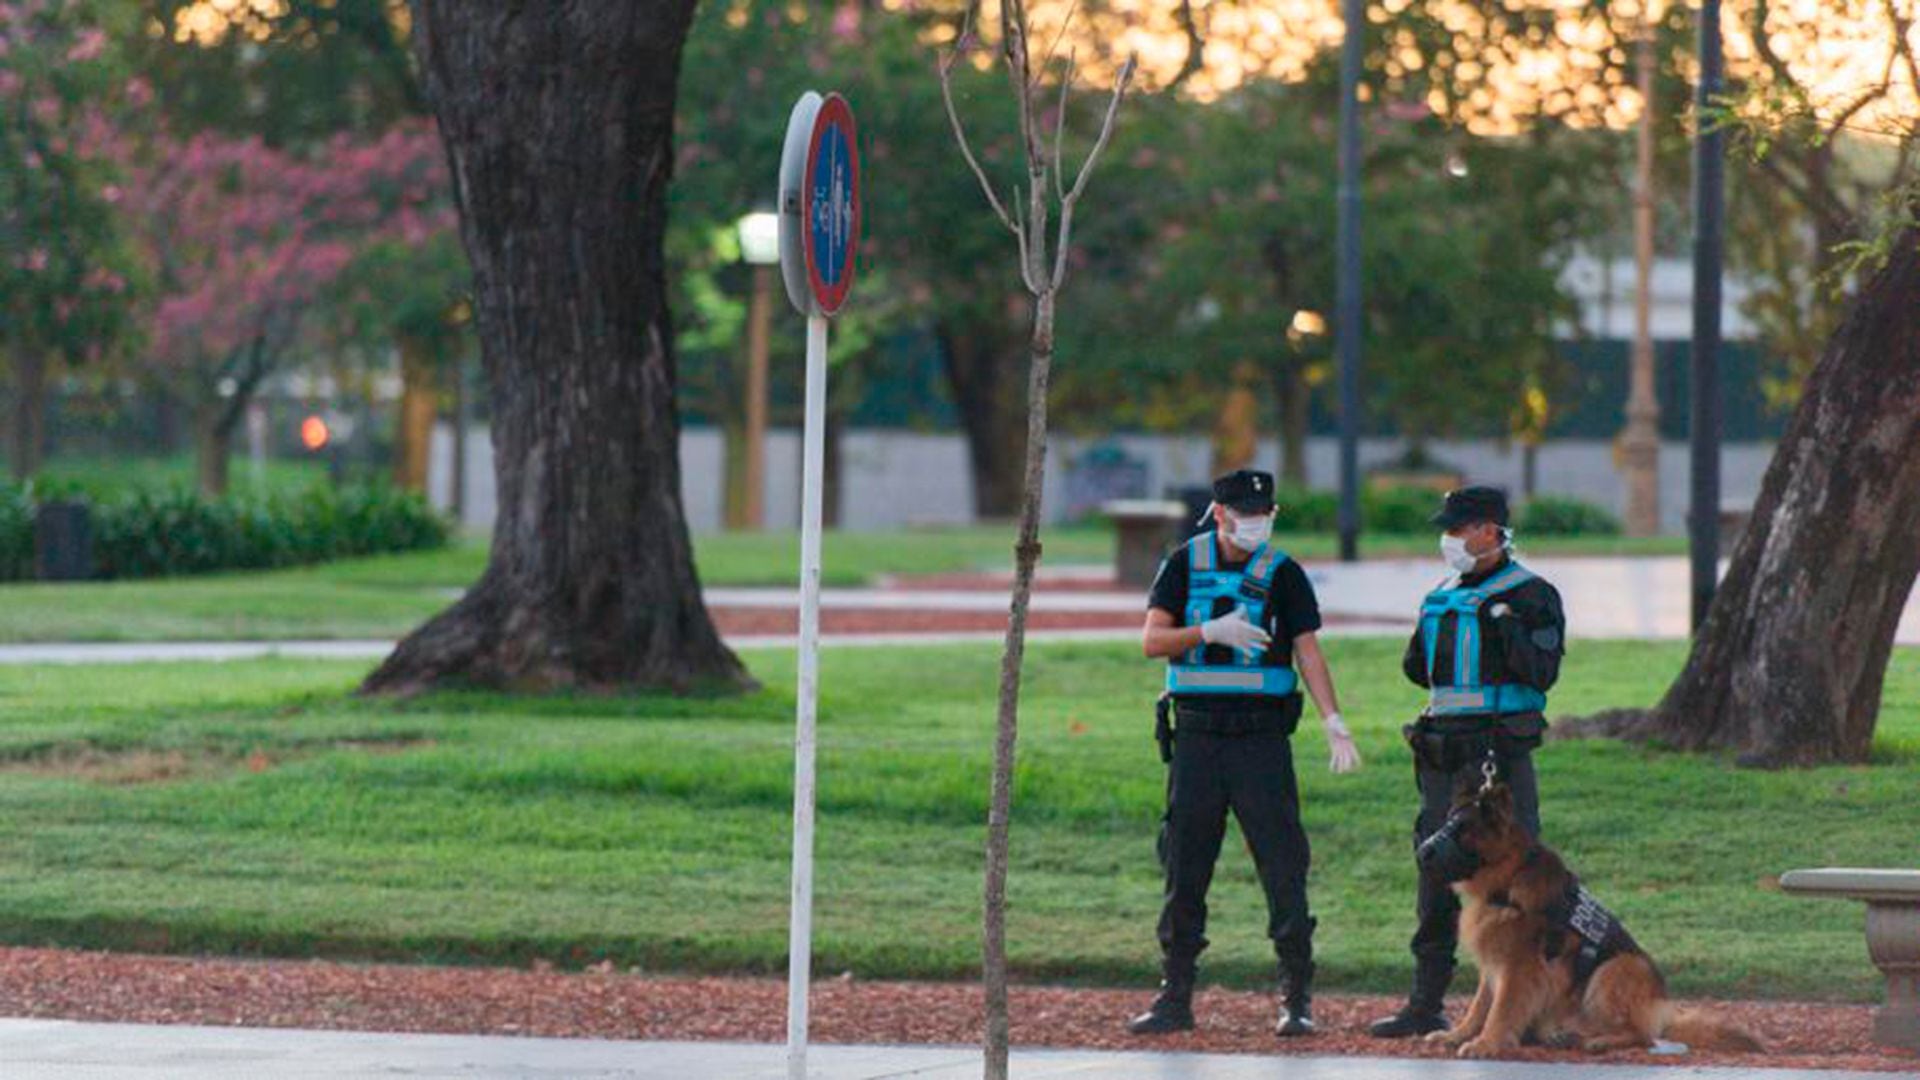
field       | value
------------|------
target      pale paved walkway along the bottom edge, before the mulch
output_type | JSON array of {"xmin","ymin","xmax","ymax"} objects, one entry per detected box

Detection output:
[{"xmin": 0, "ymin": 1020, "xmax": 1887, "ymax": 1080}]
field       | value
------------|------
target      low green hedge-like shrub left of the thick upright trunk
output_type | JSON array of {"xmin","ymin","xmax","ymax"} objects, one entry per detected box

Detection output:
[{"xmin": 94, "ymin": 484, "xmax": 451, "ymax": 578}]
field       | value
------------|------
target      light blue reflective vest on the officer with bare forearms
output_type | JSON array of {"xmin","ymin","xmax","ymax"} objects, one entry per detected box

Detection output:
[{"xmin": 1167, "ymin": 530, "xmax": 1300, "ymax": 698}]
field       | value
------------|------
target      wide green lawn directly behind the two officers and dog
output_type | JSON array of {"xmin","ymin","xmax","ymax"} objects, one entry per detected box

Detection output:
[{"xmin": 0, "ymin": 638, "xmax": 1920, "ymax": 999}]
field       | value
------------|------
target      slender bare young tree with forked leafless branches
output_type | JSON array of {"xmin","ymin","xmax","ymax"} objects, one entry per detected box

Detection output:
[{"xmin": 939, "ymin": 0, "xmax": 1135, "ymax": 1080}]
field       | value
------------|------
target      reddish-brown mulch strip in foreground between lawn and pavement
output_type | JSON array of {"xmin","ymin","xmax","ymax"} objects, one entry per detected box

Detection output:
[{"xmin": 0, "ymin": 949, "xmax": 1920, "ymax": 1074}]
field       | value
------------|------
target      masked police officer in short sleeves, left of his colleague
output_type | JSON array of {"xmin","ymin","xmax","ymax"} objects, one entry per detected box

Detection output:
[{"xmin": 1129, "ymin": 469, "xmax": 1359, "ymax": 1036}]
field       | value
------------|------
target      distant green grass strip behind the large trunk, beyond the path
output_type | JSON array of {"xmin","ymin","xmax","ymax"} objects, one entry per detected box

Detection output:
[{"xmin": 0, "ymin": 525, "xmax": 1684, "ymax": 644}]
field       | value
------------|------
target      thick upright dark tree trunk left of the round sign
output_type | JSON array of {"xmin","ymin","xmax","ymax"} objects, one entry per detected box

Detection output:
[{"xmin": 363, "ymin": 0, "xmax": 751, "ymax": 692}]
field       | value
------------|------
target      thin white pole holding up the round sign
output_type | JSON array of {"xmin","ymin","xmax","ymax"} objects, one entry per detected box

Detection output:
[{"xmin": 787, "ymin": 307, "xmax": 828, "ymax": 1080}]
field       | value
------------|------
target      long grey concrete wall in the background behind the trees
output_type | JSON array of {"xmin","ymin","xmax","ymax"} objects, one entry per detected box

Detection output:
[{"xmin": 428, "ymin": 425, "xmax": 1772, "ymax": 532}]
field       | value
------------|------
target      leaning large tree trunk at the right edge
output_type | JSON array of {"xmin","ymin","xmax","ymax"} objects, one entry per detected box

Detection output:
[{"xmin": 1572, "ymin": 229, "xmax": 1920, "ymax": 765}]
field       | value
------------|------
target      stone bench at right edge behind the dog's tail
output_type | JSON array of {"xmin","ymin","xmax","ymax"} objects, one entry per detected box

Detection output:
[{"xmin": 1780, "ymin": 869, "xmax": 1920, "ymax": 1049}]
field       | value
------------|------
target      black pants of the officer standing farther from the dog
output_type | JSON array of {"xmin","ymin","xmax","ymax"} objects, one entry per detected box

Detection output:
[{"xmin": 1160, "ymin": 728, "xmax": 1313, "ymax": 963}]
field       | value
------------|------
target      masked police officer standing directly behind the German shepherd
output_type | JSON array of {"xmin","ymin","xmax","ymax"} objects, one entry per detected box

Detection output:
[{"xmin": 1369, "ymin": 488, "xmax": 1567, "ymax": 1038}]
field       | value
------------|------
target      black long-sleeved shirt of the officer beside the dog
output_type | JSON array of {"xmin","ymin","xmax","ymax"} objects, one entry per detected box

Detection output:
[{"xmin": 1402, "ymin": 559, "xmax": 1567, "ymax": 723}]
